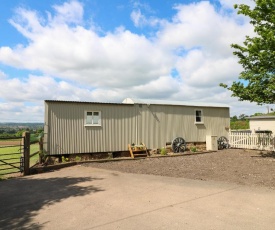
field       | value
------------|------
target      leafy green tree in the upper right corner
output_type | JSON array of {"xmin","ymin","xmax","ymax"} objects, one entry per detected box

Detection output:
[{"xmin": 220, "ymin": 0, "xmax": 275, "ymax": 104}]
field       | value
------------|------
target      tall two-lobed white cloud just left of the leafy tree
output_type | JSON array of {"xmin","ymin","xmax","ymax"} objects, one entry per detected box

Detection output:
[{"xmin": 158, "ymin": 1, "xmax": 253, "ymax": 92}]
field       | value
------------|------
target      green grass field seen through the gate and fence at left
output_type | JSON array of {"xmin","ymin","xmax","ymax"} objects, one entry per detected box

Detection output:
[{"xmin": 0, "ymin": 139, "xmax": 39, "ymax": 177}]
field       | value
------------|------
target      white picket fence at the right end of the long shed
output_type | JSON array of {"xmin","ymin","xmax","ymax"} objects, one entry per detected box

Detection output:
[{"xmin": 228, "ymin": 132, "xmax": 275, "ymax": 151}]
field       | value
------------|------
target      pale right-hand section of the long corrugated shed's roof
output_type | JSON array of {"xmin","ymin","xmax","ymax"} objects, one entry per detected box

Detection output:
[{"xmin": 122, "ymin": 98, "xmax": 229, "ymax": 108}]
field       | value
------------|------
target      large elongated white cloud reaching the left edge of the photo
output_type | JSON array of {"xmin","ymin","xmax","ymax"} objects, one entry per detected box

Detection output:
[{"xmin": 0, "ymin": 9, "xmax": 171, "ymax": 87}]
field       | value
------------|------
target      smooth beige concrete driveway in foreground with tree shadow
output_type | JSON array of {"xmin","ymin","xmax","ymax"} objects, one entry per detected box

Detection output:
[{"xmin": 0, "ymin": 166, "xmax": 275, "ymax": 230}]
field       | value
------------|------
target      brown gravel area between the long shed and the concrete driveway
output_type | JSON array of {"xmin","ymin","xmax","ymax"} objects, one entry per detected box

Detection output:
[{"xmin": 85, "ymin": 149, "xmax": 275, "ymax": 189}]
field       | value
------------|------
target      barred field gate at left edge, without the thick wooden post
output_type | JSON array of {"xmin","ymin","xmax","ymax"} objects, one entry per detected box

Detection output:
[{"xmin": 0, "ymin": 137, "xmax": 25, "ymax": 177}]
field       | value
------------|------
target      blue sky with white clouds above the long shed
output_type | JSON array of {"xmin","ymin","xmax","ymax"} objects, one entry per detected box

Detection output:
[{"xmin": 0, "ymin": 0, "xmax": 272, "ymax": 122}]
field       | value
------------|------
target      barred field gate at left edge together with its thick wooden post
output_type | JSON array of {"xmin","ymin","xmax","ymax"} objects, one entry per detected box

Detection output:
[{"xmin": 0, "ymin": 132, "xmax": 30, "ymax": 177}]
